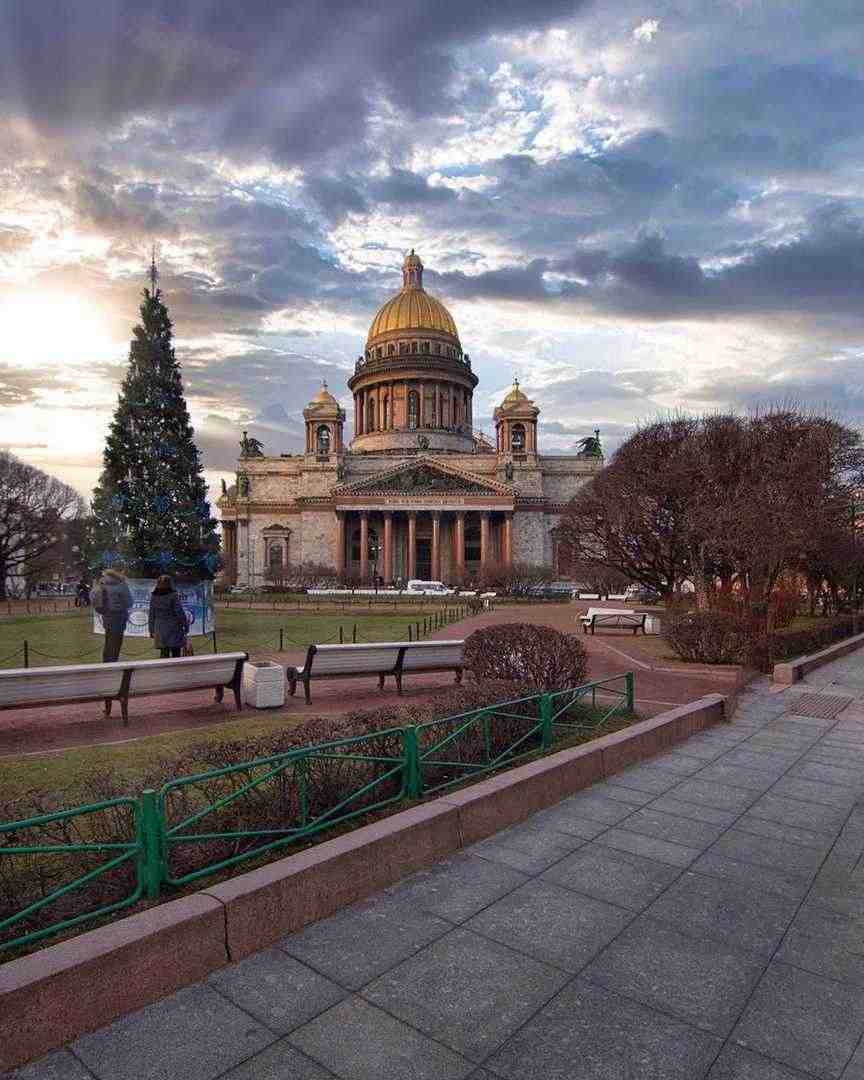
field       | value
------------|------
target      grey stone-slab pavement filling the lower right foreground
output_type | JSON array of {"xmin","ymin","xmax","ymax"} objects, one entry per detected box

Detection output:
[{"xmin": 6, "ymin": 653, "xmax": 864, "ymax": 1080}]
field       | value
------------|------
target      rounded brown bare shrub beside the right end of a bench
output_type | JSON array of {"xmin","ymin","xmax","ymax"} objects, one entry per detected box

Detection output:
[{"xmin": 464, "ymin": 623, "xmax": 588, "ymax": 692}]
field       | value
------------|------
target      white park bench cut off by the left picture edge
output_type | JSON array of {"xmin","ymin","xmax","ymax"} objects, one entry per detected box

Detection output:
[{"xmin": 0, "ymin": 652, "xmax": 248, "ymax": 725}]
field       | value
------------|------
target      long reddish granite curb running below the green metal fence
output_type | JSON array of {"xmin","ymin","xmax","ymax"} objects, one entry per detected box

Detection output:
[{"xmin": 0, "ymin": 693, "xmax": 733, "ymax": 1070}]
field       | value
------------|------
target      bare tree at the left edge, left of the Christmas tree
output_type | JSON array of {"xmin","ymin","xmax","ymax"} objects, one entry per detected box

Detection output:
[{"xmin": 0, "ymin": 450, "xmax": 84, "ymax": 598}]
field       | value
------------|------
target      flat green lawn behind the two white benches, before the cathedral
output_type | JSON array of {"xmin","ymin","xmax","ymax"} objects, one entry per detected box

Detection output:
[{"xmin": 0, "ymin": 608, "xmax": 436, "ymax": 667}]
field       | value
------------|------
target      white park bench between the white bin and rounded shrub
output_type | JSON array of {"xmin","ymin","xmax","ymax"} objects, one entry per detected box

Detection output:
[{"xmin": 285, "ymin": 642, "xmax": 463, "ymax": 705}]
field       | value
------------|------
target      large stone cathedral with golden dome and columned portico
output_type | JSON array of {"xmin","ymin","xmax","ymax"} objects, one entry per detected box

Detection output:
[{"xmin": 218, "ymin": 251, "xmax": 603, "ymax": 585}]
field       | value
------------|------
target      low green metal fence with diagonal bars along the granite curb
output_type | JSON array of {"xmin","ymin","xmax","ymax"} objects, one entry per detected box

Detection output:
[{"xmin": 0, "ymin": 673, "xmax": 634, "ymax": 951}]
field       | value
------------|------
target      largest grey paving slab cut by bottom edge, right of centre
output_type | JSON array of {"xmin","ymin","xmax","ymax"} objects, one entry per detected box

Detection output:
[{"xmin": 487, "ymin": 978, "xmax": 721, "ymax": 1080}]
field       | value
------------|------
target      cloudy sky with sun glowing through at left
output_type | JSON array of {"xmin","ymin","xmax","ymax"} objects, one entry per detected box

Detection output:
[{"xmin": 0, "ymin": 0, "xmax": 864, "ymax": 494}]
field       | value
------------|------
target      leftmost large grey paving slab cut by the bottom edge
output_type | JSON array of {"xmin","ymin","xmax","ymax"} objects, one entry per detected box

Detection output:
[{"xmin": 71, "ymin": 984, "xmax": 276, "ymax": 1080}]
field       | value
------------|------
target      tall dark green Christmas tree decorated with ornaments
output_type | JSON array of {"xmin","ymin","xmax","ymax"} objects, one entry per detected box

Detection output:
[{"xmin": 92, "ymin": 282, "xmax": 220, "ymax": 580}]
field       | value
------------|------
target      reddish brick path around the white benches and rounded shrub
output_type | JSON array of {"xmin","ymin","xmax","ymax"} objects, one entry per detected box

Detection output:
[{"xmin": 0, "ymin": 605, "xmax": 730, "ymax": 757}]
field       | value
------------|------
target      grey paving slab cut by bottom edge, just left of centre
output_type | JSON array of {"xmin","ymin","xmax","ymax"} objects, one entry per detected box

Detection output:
[{"xmin": 288, "ymin": 998, "xmax": 475, "ymax": 1080}]
